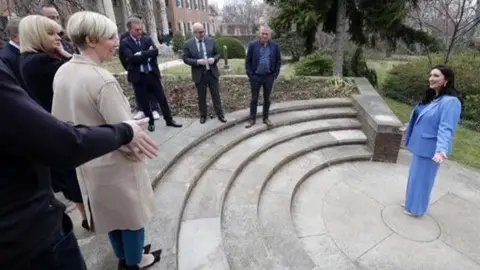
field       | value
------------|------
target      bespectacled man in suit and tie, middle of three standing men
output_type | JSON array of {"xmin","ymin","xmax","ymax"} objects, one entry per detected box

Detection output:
[{"xmin": 183, "ymin": 22, "xmax": 227, "ymax": 124}]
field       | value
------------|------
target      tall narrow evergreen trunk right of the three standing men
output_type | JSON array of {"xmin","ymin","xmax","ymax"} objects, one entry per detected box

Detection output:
[{"xmin": 333, "ymin": 0, "xmax": 347, "ymax": 77}]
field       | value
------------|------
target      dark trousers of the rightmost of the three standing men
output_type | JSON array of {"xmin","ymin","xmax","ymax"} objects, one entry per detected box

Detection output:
[{"xmin": 250, "ymin": 75, "xmax": 275, "ymax": 121}]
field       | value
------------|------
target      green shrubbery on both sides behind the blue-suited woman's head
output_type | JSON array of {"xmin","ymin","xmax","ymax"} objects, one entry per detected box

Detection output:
[{"xmin": 383, "ymin": 52, "xmax": 480, "ymax": 130}]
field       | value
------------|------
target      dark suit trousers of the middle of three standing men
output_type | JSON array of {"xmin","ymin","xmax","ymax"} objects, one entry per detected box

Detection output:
[{"xmin": 195, "ymin": 71, "xmax": 223, "ymax": 116}]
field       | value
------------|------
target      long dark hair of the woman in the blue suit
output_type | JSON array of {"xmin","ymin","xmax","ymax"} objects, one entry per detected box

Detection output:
[{"xmin": 420, "ymin": 65, "xmax": 465, "ymax": 111}]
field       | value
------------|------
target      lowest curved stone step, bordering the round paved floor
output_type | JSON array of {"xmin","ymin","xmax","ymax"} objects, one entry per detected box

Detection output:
[{"xmin": 258, "ymin": 144, "xmax": 372, "ymax": 270}]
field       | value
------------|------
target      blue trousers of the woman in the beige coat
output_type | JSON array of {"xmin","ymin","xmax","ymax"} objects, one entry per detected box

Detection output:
[{"xmin": 108, "ymin": 228, "xmax": 145, "ymax": 266}]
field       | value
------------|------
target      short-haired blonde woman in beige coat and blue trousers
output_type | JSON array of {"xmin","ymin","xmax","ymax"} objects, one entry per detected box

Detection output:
[{"xmin": 52, "ymin": 11, "xmax": 161, "ymax": 269}]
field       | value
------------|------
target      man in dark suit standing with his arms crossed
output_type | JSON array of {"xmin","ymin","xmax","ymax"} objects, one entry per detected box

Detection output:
[{"xmin": 120, "ymin": 17, "xmax": 182, "ymax": 131}]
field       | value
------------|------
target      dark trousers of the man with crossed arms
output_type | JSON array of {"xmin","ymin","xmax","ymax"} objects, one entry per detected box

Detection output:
[{"xmin": 133, "ymin": 73, "xmax": 172, "ymax": 124}]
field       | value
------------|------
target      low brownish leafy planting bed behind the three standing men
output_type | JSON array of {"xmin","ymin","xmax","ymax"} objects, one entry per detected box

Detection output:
[{"xmin": 115, "ymin": 74, "xmax": 358, "ymax": 117}]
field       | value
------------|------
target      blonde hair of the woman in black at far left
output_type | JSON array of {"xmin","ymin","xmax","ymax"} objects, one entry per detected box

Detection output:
[{"xmin": 18, "ymin": 15, "xmax": 62, "ymax": 52}]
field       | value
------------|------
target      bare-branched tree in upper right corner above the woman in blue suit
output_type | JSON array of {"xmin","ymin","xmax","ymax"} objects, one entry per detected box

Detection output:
[{"xmin": 410, "ymin": 0, "xmax": 480, "ymax": 63}]
